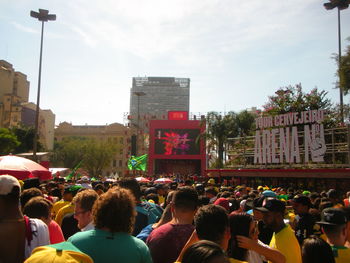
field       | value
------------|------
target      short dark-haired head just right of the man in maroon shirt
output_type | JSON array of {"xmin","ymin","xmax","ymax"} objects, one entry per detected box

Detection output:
[{"xmin": 194, "ymin": 205, "xmax": 230, "ymax": 250}]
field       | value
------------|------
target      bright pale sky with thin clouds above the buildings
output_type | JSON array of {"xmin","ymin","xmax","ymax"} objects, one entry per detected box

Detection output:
[{"xmin": 0, "ymin": 0, "xmax": 350, "ymax": 125}]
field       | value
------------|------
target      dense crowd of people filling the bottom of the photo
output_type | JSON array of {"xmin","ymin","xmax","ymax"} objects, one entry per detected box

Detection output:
[{"xmin": 0, "ymin": 175, "xmax": 350, "ymax": 263}]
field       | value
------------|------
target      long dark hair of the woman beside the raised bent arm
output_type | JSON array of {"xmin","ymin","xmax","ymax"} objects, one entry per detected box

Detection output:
[{"xmin": 227, "ymin": 213, "xmax": 253, "ymax": 261}]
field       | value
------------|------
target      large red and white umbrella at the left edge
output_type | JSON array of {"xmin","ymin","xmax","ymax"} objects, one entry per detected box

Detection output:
[{"xmin": 0, "ymin": 155, "xmax": 52, "ymax": 181}]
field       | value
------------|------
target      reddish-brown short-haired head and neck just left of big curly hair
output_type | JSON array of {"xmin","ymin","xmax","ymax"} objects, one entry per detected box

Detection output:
[{"xmin": 72, "ymin": 189, "xmax": 98, "ymax": 229}]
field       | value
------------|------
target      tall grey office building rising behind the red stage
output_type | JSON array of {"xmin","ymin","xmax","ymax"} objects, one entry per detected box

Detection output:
[{"xmin": 129, "ymin": 77, "xmax": 190, "ymax": 133}]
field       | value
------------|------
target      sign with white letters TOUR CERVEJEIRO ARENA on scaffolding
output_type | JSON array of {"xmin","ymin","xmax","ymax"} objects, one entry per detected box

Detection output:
[{"xmin": 254, "ymin": 110, "xmax": 326, "ymax": 164}]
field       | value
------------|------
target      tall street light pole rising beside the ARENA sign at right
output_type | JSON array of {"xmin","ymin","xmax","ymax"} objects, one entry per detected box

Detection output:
[{"xmin": 323, "ymin": 0, "xmax": 350, "ymax": 125}]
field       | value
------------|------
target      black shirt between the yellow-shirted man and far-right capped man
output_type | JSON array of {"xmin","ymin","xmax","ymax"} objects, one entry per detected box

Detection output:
[{"xmin": 294, "ymin": 213, "xmax": 315, "ymax": 245}]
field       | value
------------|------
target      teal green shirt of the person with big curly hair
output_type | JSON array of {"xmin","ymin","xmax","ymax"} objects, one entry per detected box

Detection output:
[{"xmin": 68, "ymin": 229, "xmax": 152, "ymax": 263}]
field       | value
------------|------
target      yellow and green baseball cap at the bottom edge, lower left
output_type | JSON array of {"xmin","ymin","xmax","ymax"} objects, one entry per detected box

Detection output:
[{"xmin": 24, "ymin": 242, "xmax": 93, "ymax": 263}]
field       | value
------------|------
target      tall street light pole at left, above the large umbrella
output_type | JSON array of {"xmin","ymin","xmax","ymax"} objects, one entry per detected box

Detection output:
[{"xmin": 30, "ymin": 9, "xmax": 56, "ymax": 161}]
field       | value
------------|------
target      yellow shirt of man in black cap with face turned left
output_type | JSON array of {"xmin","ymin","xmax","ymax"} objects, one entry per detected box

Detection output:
[{"xmin": 269, "ymin": 225, "xmax": 302, "ymax": 263}]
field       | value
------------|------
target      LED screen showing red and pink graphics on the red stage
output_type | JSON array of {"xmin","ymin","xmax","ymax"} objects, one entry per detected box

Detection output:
[{"xmin": 154, "ymin": 129, "xmax": 200, "ymax": 155}]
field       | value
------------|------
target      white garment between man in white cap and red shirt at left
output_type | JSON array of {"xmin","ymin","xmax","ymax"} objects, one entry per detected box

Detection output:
[{"xmin": 24, "ymin": 218, "xmax": 50, "ymax": 258}]
